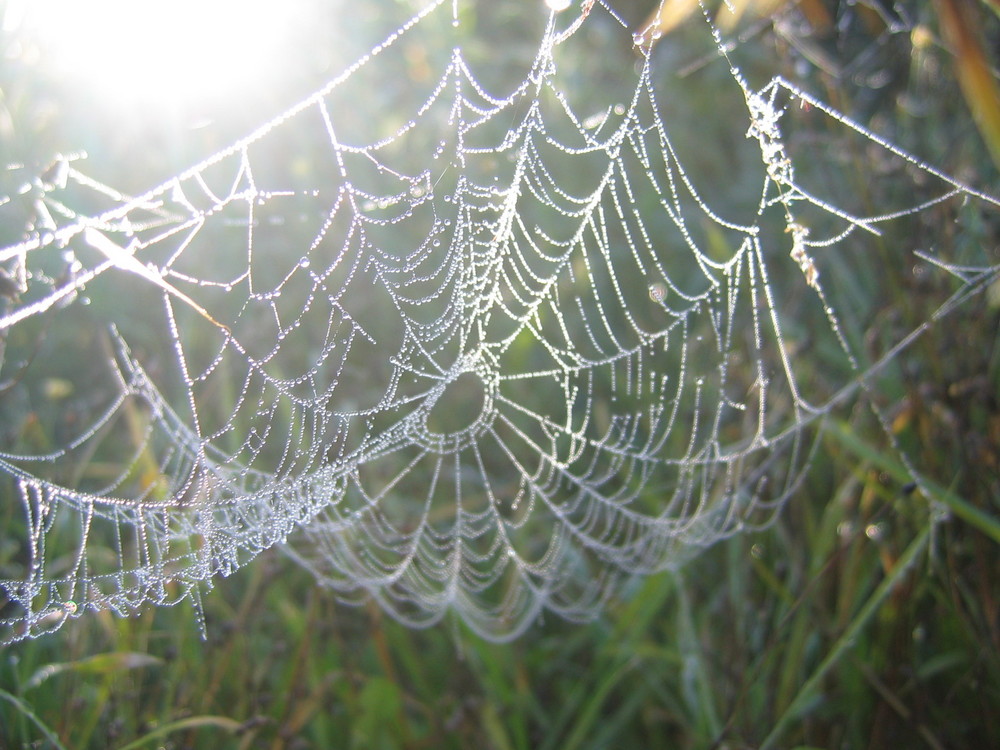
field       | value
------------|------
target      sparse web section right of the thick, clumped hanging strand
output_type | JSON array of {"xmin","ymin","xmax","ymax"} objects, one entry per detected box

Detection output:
[{"xmin": 736, "ymin": 74, "xmax": 1000, "ymax": 390}]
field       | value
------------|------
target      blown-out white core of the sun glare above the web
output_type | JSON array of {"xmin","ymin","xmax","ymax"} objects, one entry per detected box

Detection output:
[{"xmin": 8, "ymin": 0, "xmax": 301, "ymax": 111}]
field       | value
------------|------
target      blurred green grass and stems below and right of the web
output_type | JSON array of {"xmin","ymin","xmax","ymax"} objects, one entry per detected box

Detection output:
[{"xmin": 0, "ymin": 0, "xmax": 1000, "ymax": 750}]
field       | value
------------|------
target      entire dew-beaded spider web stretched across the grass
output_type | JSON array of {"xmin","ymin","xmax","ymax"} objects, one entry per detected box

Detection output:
[{"xmin": 0, "ymin": 0, "xmax": 998, "ymax": 642}]
